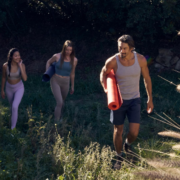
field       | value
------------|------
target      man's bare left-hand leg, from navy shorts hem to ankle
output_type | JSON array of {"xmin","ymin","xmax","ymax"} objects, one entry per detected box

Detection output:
[{"xmin": 113, "ymin": 125, "xmax": 124, "ymax": 155}]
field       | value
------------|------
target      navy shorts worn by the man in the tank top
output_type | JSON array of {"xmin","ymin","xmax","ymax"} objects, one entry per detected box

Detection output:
[{"xmin": 110, "ymin": 98, "xmax": 141, "ymax": 125}]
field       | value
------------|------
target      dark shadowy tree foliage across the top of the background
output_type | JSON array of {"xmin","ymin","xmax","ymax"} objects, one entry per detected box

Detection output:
[{"xmin": 0, "ymin": 0, "xmax": 180, "ymax": 43}]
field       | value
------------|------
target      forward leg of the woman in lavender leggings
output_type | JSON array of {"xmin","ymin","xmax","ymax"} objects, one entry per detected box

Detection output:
[{"xmin": 11, "ymin": 86, "xmax": 24, "ymax": 129}]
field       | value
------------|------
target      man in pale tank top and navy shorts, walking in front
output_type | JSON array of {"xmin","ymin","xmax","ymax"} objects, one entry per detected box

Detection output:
[{"xmin": 100, "ymin": 35, "xmax": 154, "ymax": 169}]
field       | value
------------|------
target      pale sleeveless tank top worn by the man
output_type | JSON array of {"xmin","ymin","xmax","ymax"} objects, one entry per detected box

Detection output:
[{"xmin": 115, "ymin": 52, "xmax": 141, "ymax": 100}]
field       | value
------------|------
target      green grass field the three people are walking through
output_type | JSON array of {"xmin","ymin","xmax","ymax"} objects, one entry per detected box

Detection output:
[{"xmin": 0, "ymin": 66, "xmax": 180, "ymax": 180}]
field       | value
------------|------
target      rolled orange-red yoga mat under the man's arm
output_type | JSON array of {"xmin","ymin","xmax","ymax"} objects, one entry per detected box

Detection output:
[{"xmin": 107, "ymin": 70, "xmax": 123, "ymax": 110}]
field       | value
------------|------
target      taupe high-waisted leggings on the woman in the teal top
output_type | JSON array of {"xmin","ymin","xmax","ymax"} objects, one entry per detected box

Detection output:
[{"xmin": 50, "ymin": 75, "xmax": 70, "ymax": 121}]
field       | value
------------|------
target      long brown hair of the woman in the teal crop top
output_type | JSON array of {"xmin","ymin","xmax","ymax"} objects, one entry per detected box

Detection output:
[{"xmin": 60, "ymin": 40, "xmax": 75, "ymax": 67}]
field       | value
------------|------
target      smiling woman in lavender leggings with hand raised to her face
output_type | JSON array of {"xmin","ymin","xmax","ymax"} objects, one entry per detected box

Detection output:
[{"xmin": 1, "ymin": 48, "xmax": 27, "ymax": 129}]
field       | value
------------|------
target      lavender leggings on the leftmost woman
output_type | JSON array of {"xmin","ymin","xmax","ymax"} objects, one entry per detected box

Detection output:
[{"xmin": 6, "ymin": 81, "xmax": 24, "ymax": 129}]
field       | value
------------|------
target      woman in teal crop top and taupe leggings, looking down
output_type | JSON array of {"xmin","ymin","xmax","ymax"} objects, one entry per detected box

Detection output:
[{"xmin": 46, "ymin": 40, "xmax": 77, "ymax": 122}]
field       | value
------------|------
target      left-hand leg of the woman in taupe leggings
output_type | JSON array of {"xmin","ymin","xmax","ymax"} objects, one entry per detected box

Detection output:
[{"xmin": 50, "ymin": 75, "xmax": 63, "ymax": 121}]
